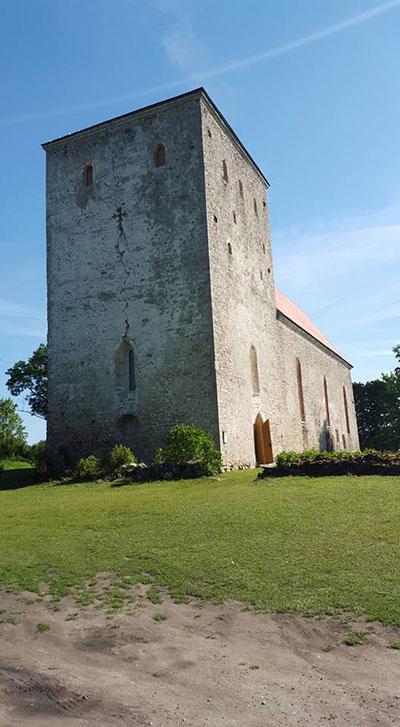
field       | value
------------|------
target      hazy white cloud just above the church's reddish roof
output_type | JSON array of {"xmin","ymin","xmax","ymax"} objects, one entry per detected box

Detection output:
[{"xmin": 272, "ymin": 207, "xmax": 400, "ymax": 380}]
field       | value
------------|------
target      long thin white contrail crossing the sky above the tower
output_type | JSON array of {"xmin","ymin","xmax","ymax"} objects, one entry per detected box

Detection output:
[{"xmin": 0, "ymin": 0, "xmax": 400, "ymax": 126}]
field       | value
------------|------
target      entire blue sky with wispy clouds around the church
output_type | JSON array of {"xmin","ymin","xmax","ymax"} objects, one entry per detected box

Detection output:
[{"xmin": 0, "ymin": 0, "xmax": 400, "ymax": 442}]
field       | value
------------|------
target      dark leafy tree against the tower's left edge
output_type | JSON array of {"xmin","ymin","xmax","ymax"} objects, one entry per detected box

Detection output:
[{"xmin": 6, "ymin": 343, "xmax": 47, "ymax": 419}]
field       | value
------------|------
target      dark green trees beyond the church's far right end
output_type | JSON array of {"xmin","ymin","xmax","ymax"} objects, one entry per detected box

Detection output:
[{"xmin": 354, "ymin": 345, "xmax": 400, "ymax": 451}]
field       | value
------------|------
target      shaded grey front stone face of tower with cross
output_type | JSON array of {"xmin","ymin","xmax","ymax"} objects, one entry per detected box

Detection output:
[{"xmin": 47, "ymin": 97, "xmax": 218, "ymax": 463}]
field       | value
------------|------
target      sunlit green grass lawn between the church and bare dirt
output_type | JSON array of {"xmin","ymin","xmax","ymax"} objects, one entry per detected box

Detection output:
[{"xmin": 0, "ymin": 471, "xmax": 400, "ymax": 625}]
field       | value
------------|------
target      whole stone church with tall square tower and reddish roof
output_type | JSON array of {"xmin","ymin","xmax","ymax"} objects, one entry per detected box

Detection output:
[{"xmin": 43, "ymin": 88, "xmax": 359, "ymax": 468}]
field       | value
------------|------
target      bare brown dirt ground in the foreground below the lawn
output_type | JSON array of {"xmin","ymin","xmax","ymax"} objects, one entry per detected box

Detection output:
[{"xmin": 0, "ymin": 587, "xmax": 400, "ymax": 727}]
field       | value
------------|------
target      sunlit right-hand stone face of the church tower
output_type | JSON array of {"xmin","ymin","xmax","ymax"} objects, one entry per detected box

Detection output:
[{"xmin": 202, "ymin": 96, "xmax": 279, "ymax": 467}]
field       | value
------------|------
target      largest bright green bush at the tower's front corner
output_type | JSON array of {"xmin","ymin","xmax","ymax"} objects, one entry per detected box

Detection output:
[{"xmin": 156, "ymin": 424, "xmax": 222, "ymax": 476}]
